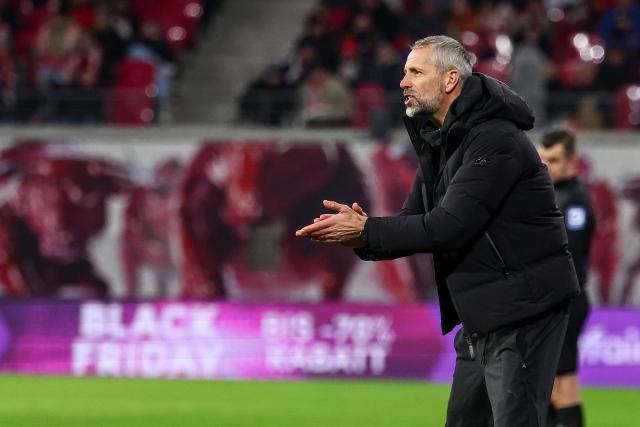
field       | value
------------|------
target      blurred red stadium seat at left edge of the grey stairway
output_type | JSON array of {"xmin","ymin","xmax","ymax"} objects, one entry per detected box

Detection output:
[{"xmin": 107, "ymin": 60, "xmax": 158, "ymax": 126}]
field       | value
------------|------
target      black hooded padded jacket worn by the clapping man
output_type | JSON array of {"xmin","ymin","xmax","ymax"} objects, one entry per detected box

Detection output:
[{"xmin": 356, "ymin": 73, "xmax": 579, "ymax": 333}]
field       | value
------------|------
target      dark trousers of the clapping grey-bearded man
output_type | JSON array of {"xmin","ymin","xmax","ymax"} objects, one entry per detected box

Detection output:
[{"xmin": 446, "ymin": 304, "xmax": 568, "ymax": 427}]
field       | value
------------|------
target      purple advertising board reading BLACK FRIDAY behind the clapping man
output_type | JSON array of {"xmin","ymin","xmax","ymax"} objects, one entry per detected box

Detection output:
[{"xmin": 0, "ymin": 301, "xmax": 640, "ymax": 387}]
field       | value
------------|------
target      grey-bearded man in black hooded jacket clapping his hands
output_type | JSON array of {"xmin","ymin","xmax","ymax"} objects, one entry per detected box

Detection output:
[{"xmin": 296, "ymin": 36, "xmax": 579, "ymax": 427}]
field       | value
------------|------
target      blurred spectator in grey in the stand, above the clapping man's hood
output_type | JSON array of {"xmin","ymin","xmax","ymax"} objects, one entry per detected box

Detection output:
[{"xmin": 509, "ymin": 28, "xmax": 547, "ymax": 127}]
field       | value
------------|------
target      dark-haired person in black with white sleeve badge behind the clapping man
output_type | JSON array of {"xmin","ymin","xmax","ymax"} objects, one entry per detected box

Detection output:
[{"xmin": 539, "ymin": 129, "xmax": 595, "ymax": 427}]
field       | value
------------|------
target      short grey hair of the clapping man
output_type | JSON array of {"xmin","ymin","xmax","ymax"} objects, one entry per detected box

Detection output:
[{"xmin": 410, "ymin": 36, "xmax": 472, "ymax": 85}]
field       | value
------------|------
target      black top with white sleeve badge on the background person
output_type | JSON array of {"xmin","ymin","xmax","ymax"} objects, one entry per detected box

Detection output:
[{"xmin": 554, "ymin": 177, "xmax": 595, "ymax": 286}]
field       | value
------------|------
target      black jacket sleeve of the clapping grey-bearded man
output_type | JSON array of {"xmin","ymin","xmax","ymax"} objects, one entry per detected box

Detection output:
[{"xmin": 365, "ymin": 130, "xmax": 523, "ymax": 254}]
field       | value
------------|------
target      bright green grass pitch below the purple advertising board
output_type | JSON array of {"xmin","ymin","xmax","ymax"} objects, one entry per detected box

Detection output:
[{"xmin": 0, "ymin": 376, "xmax": 640, "ymax": 427}]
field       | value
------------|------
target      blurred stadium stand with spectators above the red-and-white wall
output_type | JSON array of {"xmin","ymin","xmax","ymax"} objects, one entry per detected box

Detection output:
[{"xmin": 0, "ymin": 0, "xmax": 640, "ymax": 128}]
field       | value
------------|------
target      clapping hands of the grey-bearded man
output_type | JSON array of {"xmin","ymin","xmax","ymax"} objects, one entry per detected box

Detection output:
[{"xmin": 296, "ymin": 200, "xmax": 367, "ymax": 248}]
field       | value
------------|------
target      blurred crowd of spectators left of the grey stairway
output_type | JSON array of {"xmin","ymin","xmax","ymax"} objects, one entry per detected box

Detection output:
[{"xmin": 0, "ymin": 0, "xmax": 217, "ymax": 124}]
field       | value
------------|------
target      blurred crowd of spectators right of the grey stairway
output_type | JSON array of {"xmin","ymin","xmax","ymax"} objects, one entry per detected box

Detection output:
[{"xmin": 240, "ymin": 0, "xmax": 640, "ymax": 134}]
